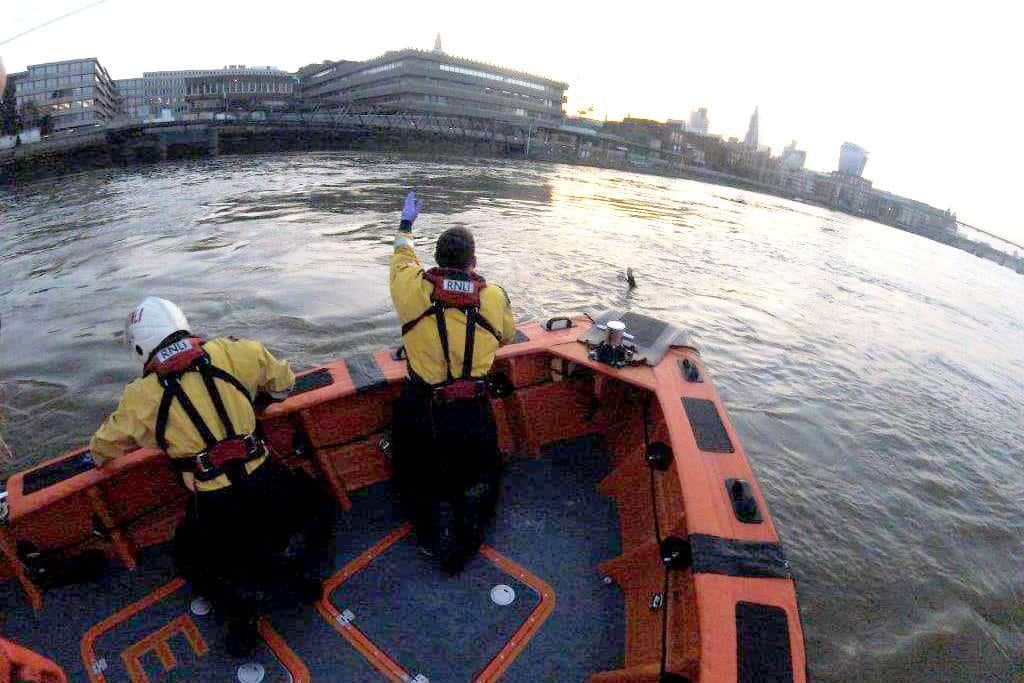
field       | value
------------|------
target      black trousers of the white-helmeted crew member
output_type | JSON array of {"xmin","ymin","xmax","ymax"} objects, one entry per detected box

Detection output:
[{"xmin": 174, "ymin": 460, "xmax": 335, "ymax": 617}]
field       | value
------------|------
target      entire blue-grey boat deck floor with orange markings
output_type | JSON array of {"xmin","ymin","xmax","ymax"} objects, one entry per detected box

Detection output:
[{"xmin": 0, "ymin": 437, "xmax": 626, "ymax": 683}]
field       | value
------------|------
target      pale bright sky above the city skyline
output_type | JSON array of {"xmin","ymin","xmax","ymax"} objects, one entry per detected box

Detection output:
[{"xmin": 0, "ymin": 0, "xmax": 1024, "ymax": 243}]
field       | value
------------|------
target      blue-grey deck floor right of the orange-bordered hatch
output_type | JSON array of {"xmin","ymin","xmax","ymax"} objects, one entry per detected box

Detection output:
[{"xmin": 487, "ymin": 437, "xmax": 626, "ymax": 683}]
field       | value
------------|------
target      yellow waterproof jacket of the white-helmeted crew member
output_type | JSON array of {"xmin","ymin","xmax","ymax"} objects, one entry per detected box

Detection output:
[{"xmin": 89, "ymin": 339, "xmax": 295, "ymax": 490}]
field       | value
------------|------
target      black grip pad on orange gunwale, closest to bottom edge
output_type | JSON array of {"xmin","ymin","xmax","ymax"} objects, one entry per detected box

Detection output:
[{"xmin": 736, "ymin": 602, "xmax": 793, "ymax": 683}]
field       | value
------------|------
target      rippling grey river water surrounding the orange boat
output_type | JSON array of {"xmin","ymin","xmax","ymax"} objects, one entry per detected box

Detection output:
[{"xmin": 0, "ymin": 154, "xmax": 1024, "ymax": 682}]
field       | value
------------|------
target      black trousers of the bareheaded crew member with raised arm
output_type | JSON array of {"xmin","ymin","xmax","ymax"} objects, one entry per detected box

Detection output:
[{"xmin": 392, "ymin": 383, "xmax": 502, "ymax": 571}]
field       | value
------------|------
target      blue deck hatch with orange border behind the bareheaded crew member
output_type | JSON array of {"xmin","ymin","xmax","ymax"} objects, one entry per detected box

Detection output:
[{"xmin": 317, "ymin": 524, "xmax": 554, "ymax": 681}]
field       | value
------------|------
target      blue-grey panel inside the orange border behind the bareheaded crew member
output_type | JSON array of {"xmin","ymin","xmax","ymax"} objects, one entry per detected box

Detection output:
[{"xmin": 330, "ymin": 537, "xmax": 540, "ymax": 681}]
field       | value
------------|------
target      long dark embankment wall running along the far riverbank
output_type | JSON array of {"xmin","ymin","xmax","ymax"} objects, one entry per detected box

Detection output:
[{"xmin": 0, "ymin": 116, "xmax": 1024, "ymax": 273}]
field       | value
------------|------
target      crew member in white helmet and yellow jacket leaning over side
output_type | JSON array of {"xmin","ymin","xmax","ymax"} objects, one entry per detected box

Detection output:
[{"xmin": 89, "ymin": 297, "xmax": 331, "ymax": 656}]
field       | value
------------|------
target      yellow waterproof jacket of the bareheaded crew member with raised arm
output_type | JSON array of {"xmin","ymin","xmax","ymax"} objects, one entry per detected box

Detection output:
[{"xmin": 391, "ymin": 231, "xmax": 515, "ymax": 384}]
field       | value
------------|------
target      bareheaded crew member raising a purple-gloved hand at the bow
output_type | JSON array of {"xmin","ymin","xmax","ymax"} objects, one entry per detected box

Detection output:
[{"xmin": 391, "ymin": 193, "xmax": 515, "ymax": 572}]
